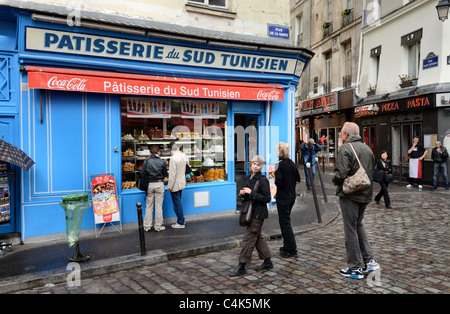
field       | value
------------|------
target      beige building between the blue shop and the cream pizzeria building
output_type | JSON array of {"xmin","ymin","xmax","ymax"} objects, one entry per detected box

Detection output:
[{"xmin": 291, "ymin": 0, "xmax": 363, "ymax": 165}]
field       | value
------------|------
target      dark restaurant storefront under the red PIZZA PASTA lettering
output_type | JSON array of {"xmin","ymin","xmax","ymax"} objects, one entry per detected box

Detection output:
[{"xmin": 355, "ymin": 93, "xmax": 450, "ymax": 184}]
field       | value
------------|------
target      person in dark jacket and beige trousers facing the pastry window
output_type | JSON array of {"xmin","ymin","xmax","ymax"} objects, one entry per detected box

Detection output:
[{"xmin": 144, "ymin": 145, "xmax": 167, "ymax": 232}]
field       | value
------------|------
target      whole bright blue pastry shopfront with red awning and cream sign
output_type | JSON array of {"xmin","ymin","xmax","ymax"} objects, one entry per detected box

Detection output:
[{"xmin": 0, "ymin": 7, "xmax": 312, "ymax": 242}]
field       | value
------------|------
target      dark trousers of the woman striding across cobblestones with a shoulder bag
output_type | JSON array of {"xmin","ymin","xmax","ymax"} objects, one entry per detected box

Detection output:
[{"xmin": 239, "ymin": 218, "xmax": 270, "ymax": 263}]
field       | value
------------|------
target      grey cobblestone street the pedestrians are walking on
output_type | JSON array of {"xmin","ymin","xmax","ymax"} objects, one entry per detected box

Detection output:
[{"xmin": 12, "ymin": 190, "xmax": 450, "ymax": 294}]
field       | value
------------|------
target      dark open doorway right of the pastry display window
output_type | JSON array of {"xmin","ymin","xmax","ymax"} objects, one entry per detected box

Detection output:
[{"xmin": 234, "ymin": 114, "xmax": 261, "ymax": 194}]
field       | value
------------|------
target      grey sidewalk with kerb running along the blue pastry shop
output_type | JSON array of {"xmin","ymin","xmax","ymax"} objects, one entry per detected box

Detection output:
[{"xmin": 0, "ymin": 180, "xmax": 338, "ymax": 293}]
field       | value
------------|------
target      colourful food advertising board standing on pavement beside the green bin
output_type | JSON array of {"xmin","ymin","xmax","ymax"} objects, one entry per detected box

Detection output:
[{"xmin": 91, "ymin": 175, "xmax": 120, "ymax": 224}]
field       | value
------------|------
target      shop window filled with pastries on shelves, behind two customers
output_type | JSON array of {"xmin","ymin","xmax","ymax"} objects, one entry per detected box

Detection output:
[{"xmin": 121, "ymin": 97, "xmax": 228, "ymax": 189}]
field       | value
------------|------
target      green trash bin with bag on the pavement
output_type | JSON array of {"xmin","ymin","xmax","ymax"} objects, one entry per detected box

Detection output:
[{"xmin": 59, "ymin": 193, "xmax": 92, "ymax": 262}]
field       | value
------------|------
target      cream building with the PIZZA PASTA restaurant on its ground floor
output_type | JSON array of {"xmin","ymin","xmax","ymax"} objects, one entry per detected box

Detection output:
[{"xmin": 355, "ymin": 0, "xmax": 450, "ymax": 184}]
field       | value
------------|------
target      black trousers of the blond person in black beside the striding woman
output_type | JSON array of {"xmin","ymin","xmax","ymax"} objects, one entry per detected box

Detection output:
[{"xmin": 277, "ymin": 198, "xmax": 297, "ymax": 253}]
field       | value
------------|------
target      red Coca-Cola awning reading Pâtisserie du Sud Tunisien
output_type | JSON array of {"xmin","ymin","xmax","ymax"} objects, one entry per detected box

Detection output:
[{"xmin": 26, "ymin": 66, "xmax": 283, "ymax": 101}]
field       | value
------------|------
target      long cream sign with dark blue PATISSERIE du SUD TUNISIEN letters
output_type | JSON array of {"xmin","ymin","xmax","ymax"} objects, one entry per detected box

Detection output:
[{"xmin": 25, "ymin": 27, "xmax": 303, "ymax": 75}]
